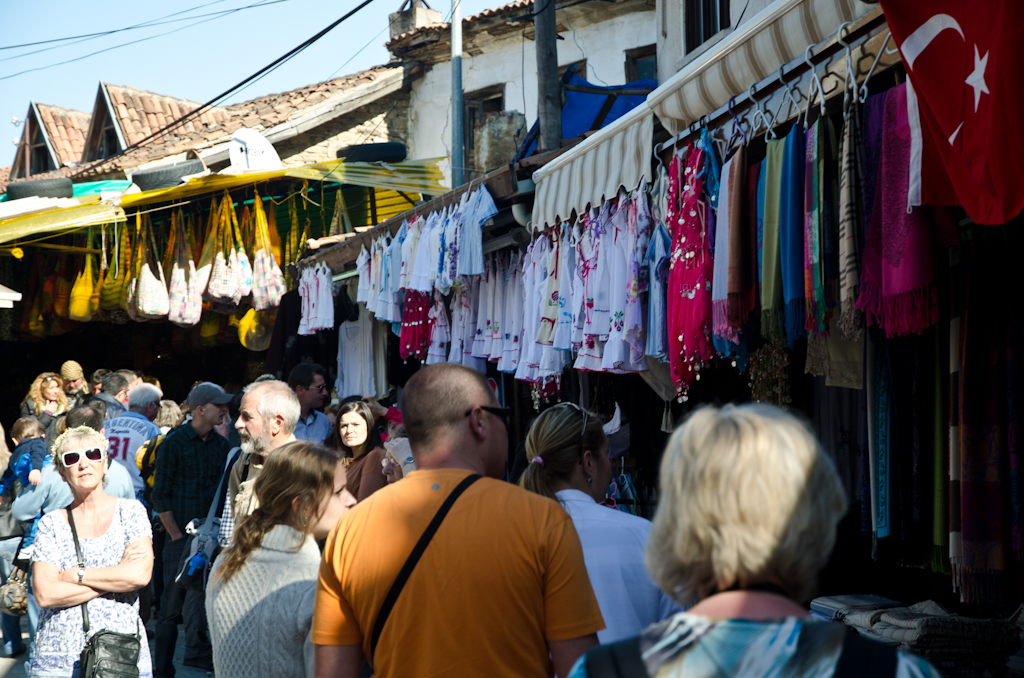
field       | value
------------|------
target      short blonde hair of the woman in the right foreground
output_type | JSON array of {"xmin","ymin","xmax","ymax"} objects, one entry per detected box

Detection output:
[{"xmin": 646, "ymin": 405, "xmax": 847, "ymax": 604}]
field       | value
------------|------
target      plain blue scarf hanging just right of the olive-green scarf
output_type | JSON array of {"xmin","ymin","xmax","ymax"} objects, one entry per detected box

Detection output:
[{"xmin": 779, "ymin": 124, "xmax": 807, "ymax": 348}]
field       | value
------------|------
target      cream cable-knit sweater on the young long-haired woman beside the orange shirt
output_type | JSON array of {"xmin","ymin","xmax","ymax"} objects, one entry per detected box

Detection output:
[{"xmin": 206, "ymin": 525, "xmax": 319, "ymax": 678}]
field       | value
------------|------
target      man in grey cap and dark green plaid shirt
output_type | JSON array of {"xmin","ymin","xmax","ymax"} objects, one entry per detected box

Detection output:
[{"xmin": 153, "ymin": 382, "xmax": 232, "ymax": 678}]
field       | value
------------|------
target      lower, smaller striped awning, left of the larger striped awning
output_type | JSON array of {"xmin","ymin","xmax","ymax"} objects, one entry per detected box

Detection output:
[{"xmin": 532, "ymin": 105, "xmax": 654, "ymax": 227}]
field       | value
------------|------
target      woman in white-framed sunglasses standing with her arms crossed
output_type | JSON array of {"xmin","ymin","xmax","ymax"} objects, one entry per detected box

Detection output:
[{"xmin": 30, "ymin": 426, "xmax": 153, "ymax": 678}]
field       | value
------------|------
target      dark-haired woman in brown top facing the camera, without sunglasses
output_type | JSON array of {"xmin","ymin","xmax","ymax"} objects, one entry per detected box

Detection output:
[{"xmin": 331, "ymin": 400, "xmax": 387, "ymax": 502}]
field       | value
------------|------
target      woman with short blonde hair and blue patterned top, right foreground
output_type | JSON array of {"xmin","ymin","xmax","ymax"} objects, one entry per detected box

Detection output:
[{"xmin": 569, "ymin": 405, "xmax": 939, "ymax": 678}]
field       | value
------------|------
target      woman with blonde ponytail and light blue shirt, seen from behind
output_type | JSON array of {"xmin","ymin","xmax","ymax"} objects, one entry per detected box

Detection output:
[{"xmin": 519, "ymin": 402, "xmax": 679, "ymax": 643}]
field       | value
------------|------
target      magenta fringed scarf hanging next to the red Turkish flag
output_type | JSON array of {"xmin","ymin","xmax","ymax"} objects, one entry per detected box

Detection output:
[{"xmin": 857, "ymin": 83, "xmax": 939, "ymax": 337}]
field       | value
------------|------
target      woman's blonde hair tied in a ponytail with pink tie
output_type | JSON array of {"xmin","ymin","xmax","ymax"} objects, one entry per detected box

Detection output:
[{"xmin": 519, "ymin": 402, "xmax": 605, "ymax": 501}]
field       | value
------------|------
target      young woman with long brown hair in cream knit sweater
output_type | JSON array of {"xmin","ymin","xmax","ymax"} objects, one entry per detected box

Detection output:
[{"xmin": 206, "ymin": 442, "xmax": 355, "ymax": 678}]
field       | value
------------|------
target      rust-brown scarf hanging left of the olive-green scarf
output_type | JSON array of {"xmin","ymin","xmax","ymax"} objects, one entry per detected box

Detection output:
[{"xmin": 720, "ymin": 146, "xmax": 754, "ymax": 333}]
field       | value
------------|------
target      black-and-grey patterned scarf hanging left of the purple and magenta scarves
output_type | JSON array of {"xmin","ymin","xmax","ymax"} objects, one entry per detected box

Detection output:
[{"xmin": 839, "ymin": 103, "xmax": 863, "ymax": 341}]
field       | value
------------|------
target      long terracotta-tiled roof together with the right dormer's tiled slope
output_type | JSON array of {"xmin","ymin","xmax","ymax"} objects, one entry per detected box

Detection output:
[{"xmin": 78, "ymin": 66, "xmax": 400, "ymax": 179}]
